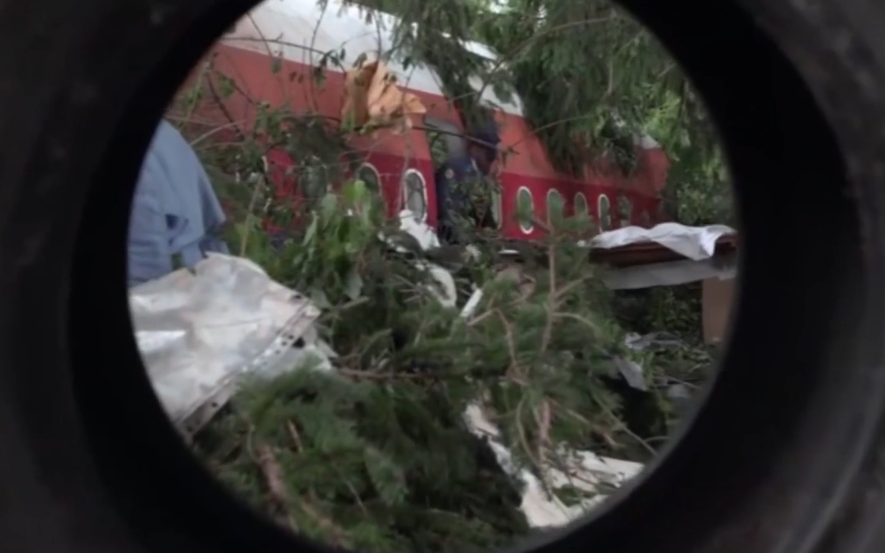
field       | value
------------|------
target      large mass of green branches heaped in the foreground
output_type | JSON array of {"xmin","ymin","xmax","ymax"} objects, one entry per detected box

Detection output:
[{"xmin": 190, "ymin": 177, "xmax": 672, "ymax": 552}]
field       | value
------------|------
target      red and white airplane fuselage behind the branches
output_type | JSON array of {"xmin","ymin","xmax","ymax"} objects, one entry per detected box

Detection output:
[{"xmin": 181, "ymin": 0, "xmax": 668, "ymax": 238}]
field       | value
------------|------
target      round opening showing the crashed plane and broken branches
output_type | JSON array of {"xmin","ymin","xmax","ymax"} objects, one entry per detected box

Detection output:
[{"xmin": 128, "ymin": 0, "xmax": 736, "ymax": 553}]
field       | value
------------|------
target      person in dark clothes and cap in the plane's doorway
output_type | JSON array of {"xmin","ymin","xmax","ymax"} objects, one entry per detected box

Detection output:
[{"xmin": 434, "ymin": 128, "xmax": 501, "ymax": 244}]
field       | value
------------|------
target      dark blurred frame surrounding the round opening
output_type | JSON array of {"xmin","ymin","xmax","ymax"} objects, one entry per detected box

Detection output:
[{"xmin": 0, "ymin": 0, "xmax": 885, "ymax": 553}]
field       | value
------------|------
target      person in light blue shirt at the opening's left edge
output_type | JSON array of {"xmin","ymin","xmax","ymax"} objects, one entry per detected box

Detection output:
[{"xmin": 128, "ymin": 120, "xmax": 228, "ymax": 286}]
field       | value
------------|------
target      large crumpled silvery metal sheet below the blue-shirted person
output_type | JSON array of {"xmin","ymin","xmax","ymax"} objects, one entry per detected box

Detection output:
[{"xmin": 129, "ymin": 254, "xmax": 331, "ymax": 435}]
